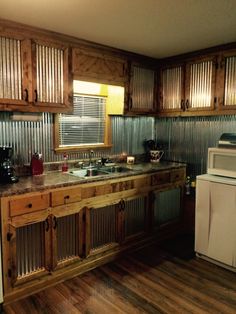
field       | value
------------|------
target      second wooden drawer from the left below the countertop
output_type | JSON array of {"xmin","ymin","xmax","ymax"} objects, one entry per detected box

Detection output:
[{"xmin": 51, "ymin": 187, "xmax": 81, "ymax": 207}]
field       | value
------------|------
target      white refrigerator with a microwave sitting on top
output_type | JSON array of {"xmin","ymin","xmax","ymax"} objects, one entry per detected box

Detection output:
[{"xmin": 195, "ymin": 174, "xmax": 236, "ymax": 271}]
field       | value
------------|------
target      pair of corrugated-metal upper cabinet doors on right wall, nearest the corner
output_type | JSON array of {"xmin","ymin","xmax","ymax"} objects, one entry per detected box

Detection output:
[{"xmin": 158, "ymin": 56, "xmax": 217, "ymax": 115}]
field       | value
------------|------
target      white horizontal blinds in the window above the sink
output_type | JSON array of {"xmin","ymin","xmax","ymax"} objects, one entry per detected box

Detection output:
[{"xmin": 59, "ymin": 95, "xmax": 106, "ymax": 147}]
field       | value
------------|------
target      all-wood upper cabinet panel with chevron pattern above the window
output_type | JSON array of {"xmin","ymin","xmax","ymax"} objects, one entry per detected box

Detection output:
[{"xmin": 72, "ymin": 48, "xmax": 128, "ymax": 86}]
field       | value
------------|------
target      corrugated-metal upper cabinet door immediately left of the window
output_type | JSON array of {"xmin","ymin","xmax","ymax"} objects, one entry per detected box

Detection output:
[{"xmin": 30, "ymin": 41, "xmax": 72, "ymax": 112}]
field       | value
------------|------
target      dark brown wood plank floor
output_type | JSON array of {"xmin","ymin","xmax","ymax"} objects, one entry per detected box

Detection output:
[{"xmin": 4, "ymin": 239, "xmax": 236, "ymax": 314}]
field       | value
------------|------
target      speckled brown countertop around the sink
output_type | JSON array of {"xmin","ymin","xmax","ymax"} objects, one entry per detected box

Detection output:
[{"xmin": 0, "ymin": 161, "xmax": 185, "ymax": 197}]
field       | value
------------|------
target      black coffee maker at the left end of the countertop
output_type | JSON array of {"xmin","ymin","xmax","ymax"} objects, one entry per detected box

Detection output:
[{"xmin": 0, "ymin": 146, "xmax": 18, "ymax": 183}]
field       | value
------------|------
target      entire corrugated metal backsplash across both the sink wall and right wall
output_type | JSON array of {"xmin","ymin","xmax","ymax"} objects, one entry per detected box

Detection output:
[{"xmin": 0, "ymin": 112, "xmax": 236, "ymax": 176}]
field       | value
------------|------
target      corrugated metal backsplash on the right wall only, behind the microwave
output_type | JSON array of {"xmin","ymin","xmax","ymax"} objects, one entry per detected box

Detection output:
[{"xmin": 156, "ymin": 116, "xmax": 236, "ymax": 176}]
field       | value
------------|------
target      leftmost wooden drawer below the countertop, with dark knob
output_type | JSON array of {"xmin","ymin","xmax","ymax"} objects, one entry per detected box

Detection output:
[{"xmin": 9, "ymin": 193, "xmax": 49, "ymax": 217}]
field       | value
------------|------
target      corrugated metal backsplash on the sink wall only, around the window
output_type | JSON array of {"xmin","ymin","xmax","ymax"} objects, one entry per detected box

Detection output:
[{"xmin": 0, "ymin": 112, "xmax": 155, "ymax": 165}]
